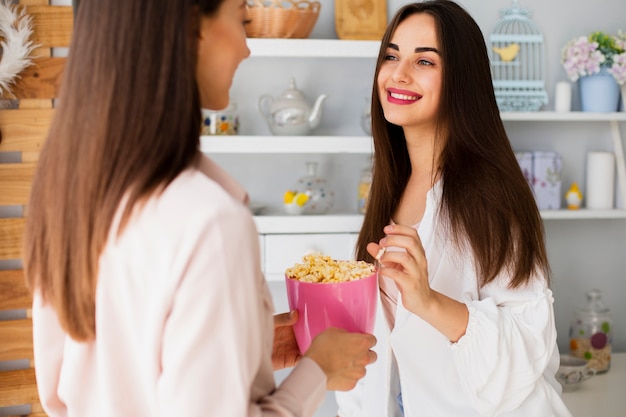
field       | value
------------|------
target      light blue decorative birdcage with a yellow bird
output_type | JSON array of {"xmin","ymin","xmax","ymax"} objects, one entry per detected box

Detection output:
[{"xmin": 489, "ymin": 0, "xmax": 548, "ymax": 111}]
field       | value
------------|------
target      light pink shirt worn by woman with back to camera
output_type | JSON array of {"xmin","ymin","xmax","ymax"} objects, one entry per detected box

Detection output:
[{"xmin": 33, "ymin": 157, "xmax": 326, "ymax": 417}]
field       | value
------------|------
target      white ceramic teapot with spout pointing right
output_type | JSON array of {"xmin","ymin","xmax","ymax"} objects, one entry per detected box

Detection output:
[{"xmin": 259, "ymin": 77, "xmax": 326, "ymax": 136}]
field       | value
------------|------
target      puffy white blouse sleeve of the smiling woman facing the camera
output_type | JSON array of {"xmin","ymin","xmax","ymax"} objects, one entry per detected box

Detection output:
[{"xmin": 451, "ymin": 277, "xmax": 556, "ymax": 415}]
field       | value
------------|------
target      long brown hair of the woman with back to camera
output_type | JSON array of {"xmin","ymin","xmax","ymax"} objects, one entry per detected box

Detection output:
[{"xmin": 24, "ymin": 0, "xmax": 222, "ymax": 341}]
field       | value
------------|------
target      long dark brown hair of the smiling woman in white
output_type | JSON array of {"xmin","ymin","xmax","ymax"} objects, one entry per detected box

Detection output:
[{"xmin": 356, "ymin": 0, "xmax": 550, "ymax": 287}]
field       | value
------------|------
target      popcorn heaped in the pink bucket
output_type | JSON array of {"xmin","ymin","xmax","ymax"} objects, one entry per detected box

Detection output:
[{"xmin": 285, "ymin": 253, "xmax": 376, "ymax": 283}]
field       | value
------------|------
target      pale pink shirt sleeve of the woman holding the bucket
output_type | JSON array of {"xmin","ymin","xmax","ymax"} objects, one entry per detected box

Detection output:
[{"xmin": 157, "ymin": 206, "xmax": 326, "ymax": 417}]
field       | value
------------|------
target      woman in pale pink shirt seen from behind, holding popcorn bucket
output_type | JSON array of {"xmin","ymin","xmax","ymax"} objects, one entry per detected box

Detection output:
[{"xmin": 24, "ymin": 0, "xmax": 375, "ymax": 417}]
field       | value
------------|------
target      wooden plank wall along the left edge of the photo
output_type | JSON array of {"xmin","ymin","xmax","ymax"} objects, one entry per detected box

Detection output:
[{"xmin": 0, "ymin": 0, "xmax": 60, "ymax": 417}]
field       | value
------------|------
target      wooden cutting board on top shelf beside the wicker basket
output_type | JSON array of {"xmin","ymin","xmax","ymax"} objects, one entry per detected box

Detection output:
[{"xmin": 335, "ymin": 0, "xmax": 387, "ymax": 40}]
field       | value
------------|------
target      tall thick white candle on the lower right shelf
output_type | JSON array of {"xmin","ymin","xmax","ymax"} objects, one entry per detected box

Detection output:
[{"xmin": 586, "ymin": 152, "xmax": 615, "ymax": 210}]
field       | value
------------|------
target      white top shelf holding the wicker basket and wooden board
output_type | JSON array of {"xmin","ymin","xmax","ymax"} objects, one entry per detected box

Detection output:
[{"xmin": 248, "ymin": 38, "xmax": 380, "ymax": 58}]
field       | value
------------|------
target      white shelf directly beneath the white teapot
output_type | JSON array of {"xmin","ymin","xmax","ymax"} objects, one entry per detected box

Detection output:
[{"xmin": 200, "ymin": 136, "xmax": 374, "ymax": 154}]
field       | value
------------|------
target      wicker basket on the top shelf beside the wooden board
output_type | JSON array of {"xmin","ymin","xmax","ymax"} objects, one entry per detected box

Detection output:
[{"xmin": 246, "ymin": 0, "xmax": 321, "ymax": 38}]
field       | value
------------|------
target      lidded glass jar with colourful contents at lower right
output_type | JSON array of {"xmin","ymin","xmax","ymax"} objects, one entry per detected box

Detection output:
[{"xmin": 569, "ymin": 290, "xmax": 613, "ymax": 373}]
